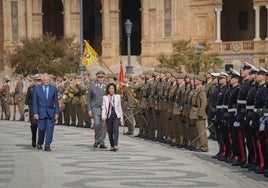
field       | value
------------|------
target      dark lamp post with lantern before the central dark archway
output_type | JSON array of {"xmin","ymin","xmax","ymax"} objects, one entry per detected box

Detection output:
[{"xmin": 125, "ymin": 19, "xmax": 133, "ymax": 74}]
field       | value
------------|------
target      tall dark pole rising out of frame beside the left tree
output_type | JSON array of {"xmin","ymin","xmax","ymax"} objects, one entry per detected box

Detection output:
[{"xmin": 79, "ymin": 0, "xmax": 85, "ymax": 77}]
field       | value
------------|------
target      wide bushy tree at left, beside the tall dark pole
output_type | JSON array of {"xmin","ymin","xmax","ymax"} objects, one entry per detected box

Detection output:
[{"xmin": 9, "ymin": 34, "xmax": 79, "ymax": 76}]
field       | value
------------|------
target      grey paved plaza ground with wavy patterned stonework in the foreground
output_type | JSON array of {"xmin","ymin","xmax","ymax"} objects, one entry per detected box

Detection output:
[{"xmin": 0, "ymin": 121, "xmax": 268, "ymax": 188}]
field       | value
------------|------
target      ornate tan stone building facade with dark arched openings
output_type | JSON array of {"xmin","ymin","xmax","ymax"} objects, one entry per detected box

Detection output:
[{"xmin": 0, "ymin": 0, "xmax": 268, "ymax": 70}]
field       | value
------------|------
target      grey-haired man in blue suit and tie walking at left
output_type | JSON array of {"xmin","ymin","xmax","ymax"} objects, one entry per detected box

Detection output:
[{"xmin": 33, "ymin": 74, "xmax": 59, "ymax": 151}]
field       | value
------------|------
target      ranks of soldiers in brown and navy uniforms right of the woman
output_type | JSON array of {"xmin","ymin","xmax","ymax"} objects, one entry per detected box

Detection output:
[{"xmin": 122, "ymin": 63, "xmax": 268, "ymax": 177}]
